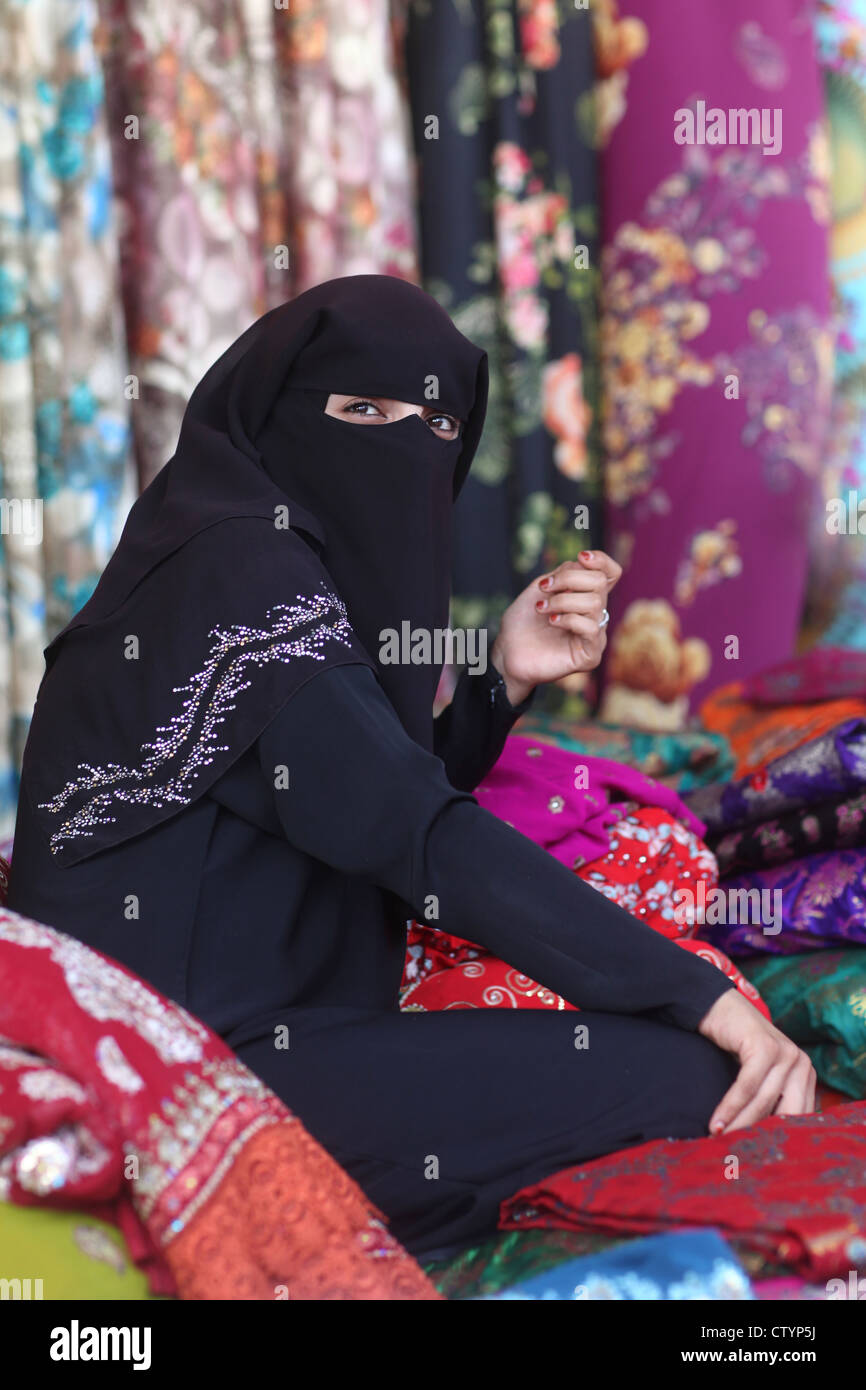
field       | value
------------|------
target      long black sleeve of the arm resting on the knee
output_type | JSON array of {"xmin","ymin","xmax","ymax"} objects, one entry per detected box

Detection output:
[{"xmin": 259, "ymin": 666, "xmax": 731, "ymax": 1029}]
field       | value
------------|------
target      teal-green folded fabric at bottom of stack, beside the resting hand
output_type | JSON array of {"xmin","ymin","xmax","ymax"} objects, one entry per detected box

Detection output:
[{"xmin": 738, "ymin": 947, "xmax": 866, "ymax": 1101}]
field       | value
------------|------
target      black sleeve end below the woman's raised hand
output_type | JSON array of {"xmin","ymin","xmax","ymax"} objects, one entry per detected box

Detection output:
[{"xmin": 434, "ymin": 664, "xmax": 534, "ymax": 791}]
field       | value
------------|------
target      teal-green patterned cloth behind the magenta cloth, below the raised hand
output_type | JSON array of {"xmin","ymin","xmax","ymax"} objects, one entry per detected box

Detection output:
[{"xmin": 514, "ymin": 709, "xmax": 734, "ymax": 792}]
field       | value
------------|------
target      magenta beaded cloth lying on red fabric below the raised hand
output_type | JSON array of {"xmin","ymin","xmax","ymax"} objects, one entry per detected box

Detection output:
[{"xmin": 475, "ymin": 734, "xmax": 705, "ymax": 869}]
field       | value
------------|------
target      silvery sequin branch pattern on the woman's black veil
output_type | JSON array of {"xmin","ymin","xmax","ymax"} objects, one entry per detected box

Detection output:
[{"xmin": 39, "ymin": 592, "xmax": 352, "ymax": 853}]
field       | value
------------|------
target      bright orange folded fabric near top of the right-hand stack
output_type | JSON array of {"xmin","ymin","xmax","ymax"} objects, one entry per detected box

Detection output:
[{"xmin": 701, "ymin": 681, "xmax": 866, "ymax": 777}]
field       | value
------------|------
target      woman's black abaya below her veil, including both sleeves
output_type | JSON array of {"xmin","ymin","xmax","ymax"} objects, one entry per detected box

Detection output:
[{"xmin": 10, "ymin": 664, "xmax": 737, "ymax": 1254}]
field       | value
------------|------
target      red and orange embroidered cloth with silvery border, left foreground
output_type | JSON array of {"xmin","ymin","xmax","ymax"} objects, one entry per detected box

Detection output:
[{"xmin": 0, "ymin": 909, "xmax": 439, "ymax": 1300}]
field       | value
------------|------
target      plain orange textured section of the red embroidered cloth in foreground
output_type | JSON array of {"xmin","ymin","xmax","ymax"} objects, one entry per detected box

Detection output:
[{"xmin": 165, "ymin": 1123, "xmax": 442, "ymax": 1301}]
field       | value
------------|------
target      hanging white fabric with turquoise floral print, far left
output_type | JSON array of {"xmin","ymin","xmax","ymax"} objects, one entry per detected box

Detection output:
[{"xmin": 0, "ymin": 0, "xmax": 133, "ymax": 833}]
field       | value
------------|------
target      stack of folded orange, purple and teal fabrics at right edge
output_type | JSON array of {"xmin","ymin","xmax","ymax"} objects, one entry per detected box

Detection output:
[{"xmin": 675, "ymin": 648, "xmax": 866, "ymax": 1098}]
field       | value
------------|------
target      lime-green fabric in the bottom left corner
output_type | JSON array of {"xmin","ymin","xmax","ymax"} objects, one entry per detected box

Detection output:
[{"xmin": 0, "ymin": 1201, "xmax": 156, "ymax": 1301}]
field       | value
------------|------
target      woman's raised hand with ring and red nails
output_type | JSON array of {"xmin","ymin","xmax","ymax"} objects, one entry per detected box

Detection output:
[{"xmin": 491, "ymin": 550, "xmax": 623, "ymax": 705}]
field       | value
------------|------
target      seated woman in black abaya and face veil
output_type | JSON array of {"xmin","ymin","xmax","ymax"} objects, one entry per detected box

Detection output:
[{"xmin": 10, "ymin": 275, "xmax": 815, "ymax": 1254}]
